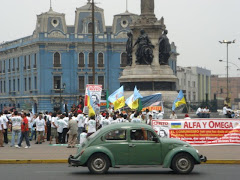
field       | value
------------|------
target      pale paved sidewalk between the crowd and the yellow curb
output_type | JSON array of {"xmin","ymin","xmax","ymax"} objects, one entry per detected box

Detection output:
[{"xmin": 0, "ymin": 141, "xmax": 240, "ymax": 163}]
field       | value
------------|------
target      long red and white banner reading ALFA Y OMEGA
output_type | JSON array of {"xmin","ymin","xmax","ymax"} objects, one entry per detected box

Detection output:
[{"xmin": 152, "ymin": 119, "xmax": 240, "ymax": 145}]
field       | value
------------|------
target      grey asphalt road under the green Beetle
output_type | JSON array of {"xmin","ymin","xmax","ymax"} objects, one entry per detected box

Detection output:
[{"xmin": 0, "ymin": 164, "xmax": 240, "ymax": 180}]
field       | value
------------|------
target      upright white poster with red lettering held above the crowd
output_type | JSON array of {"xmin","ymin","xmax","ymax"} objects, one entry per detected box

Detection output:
[{"xmin": 83, "ymin": 84, "xmax": 102, "ymax": 114}]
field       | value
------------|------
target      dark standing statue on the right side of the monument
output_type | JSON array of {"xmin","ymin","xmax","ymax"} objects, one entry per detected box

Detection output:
[{"xmin": 159, "ymin": 30, "xmax": 171, "ymax": 65}]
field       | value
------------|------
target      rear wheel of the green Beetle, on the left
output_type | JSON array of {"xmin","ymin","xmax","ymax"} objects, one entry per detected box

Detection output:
[{"xmin": 87, "ymin": 154, "xmax": 110, "ymax": 174}]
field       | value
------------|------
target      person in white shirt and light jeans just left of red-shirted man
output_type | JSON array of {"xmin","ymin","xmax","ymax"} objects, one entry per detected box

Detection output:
[{"xmin": 10, "ymin": 111, "xmax": 22, "ymax": 147}]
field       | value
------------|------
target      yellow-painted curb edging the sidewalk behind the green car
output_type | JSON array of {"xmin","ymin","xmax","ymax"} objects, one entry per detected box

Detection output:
[{"xmin": 0, "ymin": 159, "xmax": 240, "ymax": 164}]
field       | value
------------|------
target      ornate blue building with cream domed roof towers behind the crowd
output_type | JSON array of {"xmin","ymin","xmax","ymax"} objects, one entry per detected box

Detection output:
[{"xmin": 0, "ymin": 2, "xmax": 176, "ymax": 111}]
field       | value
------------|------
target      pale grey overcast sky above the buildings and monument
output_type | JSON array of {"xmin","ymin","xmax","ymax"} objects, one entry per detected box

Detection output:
[{"xmin": 0, "ymin": 0, "xmax": 240, "ymax": 76}]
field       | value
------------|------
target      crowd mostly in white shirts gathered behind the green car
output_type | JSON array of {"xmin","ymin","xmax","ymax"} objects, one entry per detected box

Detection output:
[{"xmin": 0, "ymin": 106, "xmax": 164, "ymax": 148}]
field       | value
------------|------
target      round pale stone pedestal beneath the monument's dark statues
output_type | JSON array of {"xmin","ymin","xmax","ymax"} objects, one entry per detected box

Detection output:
[{"xmin": 119, "ymin": 65, "xmax": 177, "ymax": 102}]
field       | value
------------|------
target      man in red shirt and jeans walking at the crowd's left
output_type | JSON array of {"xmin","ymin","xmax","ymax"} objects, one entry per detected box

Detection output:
[{"xmin": 16, "ymin": 113, "xmax": 31, "ymax": 149}]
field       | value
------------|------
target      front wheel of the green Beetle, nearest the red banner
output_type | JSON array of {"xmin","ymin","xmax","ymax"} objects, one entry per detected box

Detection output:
[{"xmin": 171, "ymin": 153, "xmax": 194, "ymax": 174}]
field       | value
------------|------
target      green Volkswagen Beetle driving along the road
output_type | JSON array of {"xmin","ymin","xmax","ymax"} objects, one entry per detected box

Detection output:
[{"xmin": 68, "ymin": 123, "xmax": 207, "ymax": 174}]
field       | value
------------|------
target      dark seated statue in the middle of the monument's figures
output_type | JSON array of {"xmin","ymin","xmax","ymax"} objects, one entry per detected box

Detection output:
[{"xmin": 133, "ymin": 29, "xmax": 154, "ymax": 65}]
